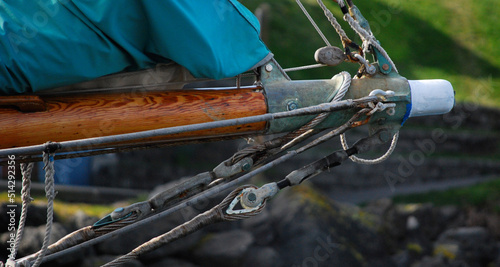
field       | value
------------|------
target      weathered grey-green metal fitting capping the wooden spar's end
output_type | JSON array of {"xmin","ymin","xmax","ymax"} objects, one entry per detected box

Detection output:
[{"xmin": 261, "ymin": 62, "xmax": 411, "ymax": 138}]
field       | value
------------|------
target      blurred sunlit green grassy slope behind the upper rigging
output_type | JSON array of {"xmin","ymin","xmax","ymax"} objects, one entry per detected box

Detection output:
[{"xmin": 242, "ymin": 0, "xmax": 500, "ymax": 107}]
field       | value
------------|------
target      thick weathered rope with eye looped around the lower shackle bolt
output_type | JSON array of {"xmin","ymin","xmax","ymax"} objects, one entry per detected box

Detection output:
[{"xmin": 103, "ymin": 186, "xmax": 265, "ymax": 267}]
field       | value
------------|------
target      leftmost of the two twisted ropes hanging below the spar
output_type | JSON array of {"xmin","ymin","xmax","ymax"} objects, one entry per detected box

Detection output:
[{"xmin": 12, "ymin": 162, "xmax": 34, "ymax": 259}]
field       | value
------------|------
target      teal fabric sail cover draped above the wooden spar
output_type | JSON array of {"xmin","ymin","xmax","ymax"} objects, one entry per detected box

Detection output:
[{"xmin": 0, "ymin": 0, "xmax": 272, "ymax": 95}]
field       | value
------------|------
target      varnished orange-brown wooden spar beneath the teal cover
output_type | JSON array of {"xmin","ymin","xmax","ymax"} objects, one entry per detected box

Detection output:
[{"xmin": 0, "ymin": 87, "xmax": 267, "ymax": 149}]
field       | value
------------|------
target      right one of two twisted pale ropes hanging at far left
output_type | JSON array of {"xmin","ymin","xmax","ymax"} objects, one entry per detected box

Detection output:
[{"xmin": 32, "ymin": 152, "xmax": 55, "ymax": 267}]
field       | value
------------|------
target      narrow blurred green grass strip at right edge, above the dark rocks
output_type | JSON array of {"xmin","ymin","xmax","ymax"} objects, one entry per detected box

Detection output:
[{"xmin": 393, "ymin": 179, "xmax": 500, "ymax": 213}]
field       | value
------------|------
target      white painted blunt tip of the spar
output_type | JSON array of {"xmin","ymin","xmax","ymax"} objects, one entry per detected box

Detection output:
[{"xmin": 408, "ymin": 79, "xmax": 455, "ymax": 117}]
